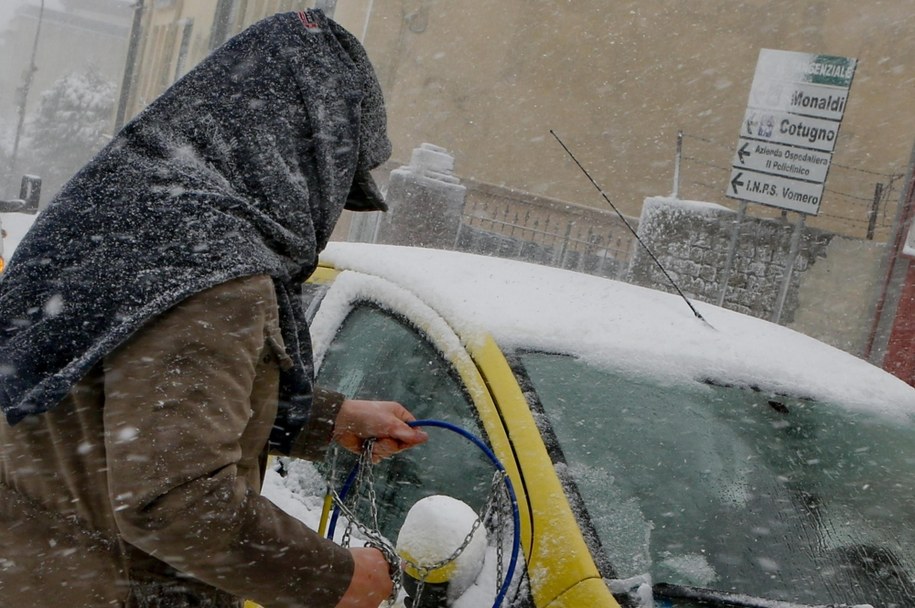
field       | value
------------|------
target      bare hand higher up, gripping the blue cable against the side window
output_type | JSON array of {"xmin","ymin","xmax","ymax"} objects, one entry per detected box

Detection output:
[{"xmin": 334, "ymin": 399, "xmax": 429, "ymax": 463}]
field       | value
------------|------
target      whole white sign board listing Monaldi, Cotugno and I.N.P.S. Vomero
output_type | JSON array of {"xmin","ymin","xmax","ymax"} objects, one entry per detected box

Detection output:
[{"xmin": 727, "ymin": 49, "xmax": 856, "ymax": 215}]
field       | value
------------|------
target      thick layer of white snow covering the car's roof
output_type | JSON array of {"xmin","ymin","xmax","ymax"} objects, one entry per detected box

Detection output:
[{"xmin": 321, "ymin": 242, "xmax": 915, "ymax": 421}]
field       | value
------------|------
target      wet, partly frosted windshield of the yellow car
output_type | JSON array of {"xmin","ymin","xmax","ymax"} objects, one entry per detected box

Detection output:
[{"xmin": 517, "ymin": 352, "xmax": 915, "ymax": 606}]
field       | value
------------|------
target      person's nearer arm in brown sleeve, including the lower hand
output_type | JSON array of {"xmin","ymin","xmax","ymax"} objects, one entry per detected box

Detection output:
[{"xmin": 104, "ymin": 277, "xmax": 356, "ymax": 608}]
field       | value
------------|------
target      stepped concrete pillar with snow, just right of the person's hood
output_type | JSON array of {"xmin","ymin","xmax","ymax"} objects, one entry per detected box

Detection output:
[{"xmin": 376, "ymin": 144, "xmax": 467, "ymax": 249}]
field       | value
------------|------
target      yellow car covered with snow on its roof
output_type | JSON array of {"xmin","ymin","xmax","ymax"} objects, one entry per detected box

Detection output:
[{"xmin": 268, "ymin": 243, "xmax": 915, "ymax": 608}]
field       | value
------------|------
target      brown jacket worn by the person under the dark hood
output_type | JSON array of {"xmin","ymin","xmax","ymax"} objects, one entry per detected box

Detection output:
[{"xmin": 0, "ymin": 276, "xmax": 353, "ymax": 608}]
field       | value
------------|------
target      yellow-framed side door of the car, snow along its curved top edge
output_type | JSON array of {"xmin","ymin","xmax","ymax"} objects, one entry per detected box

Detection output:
[{"xmin": 306, "ymin": 271, "xmax": 530, "ymax": 605}]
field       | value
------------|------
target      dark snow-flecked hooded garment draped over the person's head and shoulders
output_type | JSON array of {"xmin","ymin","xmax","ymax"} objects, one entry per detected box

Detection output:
[{"xmin": 0, "ymin": 11, "xmax": 390, "ymax": 449}]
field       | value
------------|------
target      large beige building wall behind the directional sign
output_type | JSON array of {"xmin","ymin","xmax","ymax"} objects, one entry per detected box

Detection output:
[{"xmin": 121, "ymin": 0, "xmax": 915, "ymax": 245}]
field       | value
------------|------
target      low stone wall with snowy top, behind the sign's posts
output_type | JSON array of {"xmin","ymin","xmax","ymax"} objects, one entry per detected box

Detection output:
[{"xmin": 626, "ymin": 197, "xmax": 884, "ymax": 356}]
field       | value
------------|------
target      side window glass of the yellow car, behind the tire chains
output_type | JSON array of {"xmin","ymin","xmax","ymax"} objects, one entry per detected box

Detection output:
[{"xmin": 317, "ymin": 305, "xmax": 493, "ymax": 538}]
